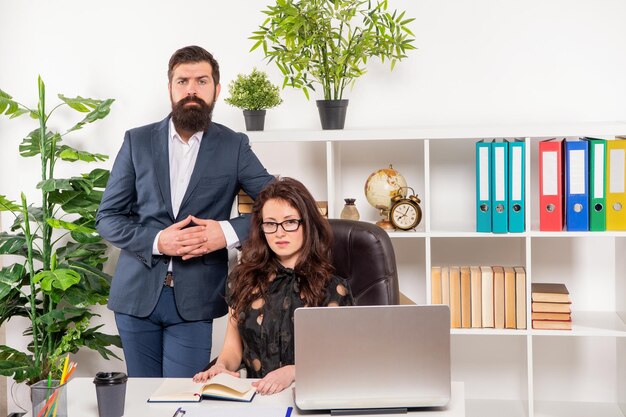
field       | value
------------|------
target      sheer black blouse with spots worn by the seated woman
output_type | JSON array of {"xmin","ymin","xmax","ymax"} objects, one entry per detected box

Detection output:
[{"xmin": 227, "ymin": 266, "xmax": 354, "ymax": 378}]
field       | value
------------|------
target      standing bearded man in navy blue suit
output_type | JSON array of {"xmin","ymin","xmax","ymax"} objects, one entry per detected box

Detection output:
[{"xmin": 96, "ymin": 46, "xmax": 273, "ymax": 377}]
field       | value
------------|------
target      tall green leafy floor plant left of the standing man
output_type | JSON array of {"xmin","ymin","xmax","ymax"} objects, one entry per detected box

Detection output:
[{"xmin": 0, "ymin": 77, "xmax": 121, "ymax": 383}]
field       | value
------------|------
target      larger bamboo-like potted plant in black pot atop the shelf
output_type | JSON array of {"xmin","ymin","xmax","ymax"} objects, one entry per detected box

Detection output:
[{"xmin": 250, "ymin": 0, "xmax": 415, "ymax": 129}]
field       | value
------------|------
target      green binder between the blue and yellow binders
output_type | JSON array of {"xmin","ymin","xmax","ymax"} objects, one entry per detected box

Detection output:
[{"xmin": 583, "ymin": 138, "xmax": 606, "ymax": 232}]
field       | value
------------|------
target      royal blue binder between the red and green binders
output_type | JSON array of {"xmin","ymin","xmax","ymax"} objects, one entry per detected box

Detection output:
[{"xmin": 565, "ymin": 140, "xmax": 589, "ymax": 231}]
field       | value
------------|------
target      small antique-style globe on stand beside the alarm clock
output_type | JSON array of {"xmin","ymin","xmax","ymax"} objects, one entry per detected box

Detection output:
[{"xmin": 365, "ymin": 165, "xmax": 407, "ymax": 229}]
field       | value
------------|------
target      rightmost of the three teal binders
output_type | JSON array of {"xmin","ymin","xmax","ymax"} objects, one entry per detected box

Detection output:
[{"xmin": 508, "ymin": 139, "xmax": 526, "ymax": 233}]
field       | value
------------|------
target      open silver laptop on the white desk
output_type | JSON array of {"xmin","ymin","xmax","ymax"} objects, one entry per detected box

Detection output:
[{"xmin": 294, "ymin": 305, "xmax": 450, "ymax": 414}]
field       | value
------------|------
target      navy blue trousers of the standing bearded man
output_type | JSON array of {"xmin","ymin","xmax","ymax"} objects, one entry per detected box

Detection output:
[{"xmin": 115, "ymin": 286, "xmax": 213, "ymax": 378}]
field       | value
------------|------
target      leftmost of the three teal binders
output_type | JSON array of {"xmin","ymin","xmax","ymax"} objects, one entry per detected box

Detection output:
[{"xmin": 476, "ymin": 140, "xmax": 492, "ymax": 232}]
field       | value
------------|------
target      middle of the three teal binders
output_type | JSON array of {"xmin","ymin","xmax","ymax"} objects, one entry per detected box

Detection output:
[{"xmin": 491, "ymin": 140, "xmax": 509, "ymax": 233}]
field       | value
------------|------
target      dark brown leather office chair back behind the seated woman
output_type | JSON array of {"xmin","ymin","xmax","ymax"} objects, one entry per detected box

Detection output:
[{"xmin": 329, "ymin": 219, "xmax": 400, "ymax": 305}]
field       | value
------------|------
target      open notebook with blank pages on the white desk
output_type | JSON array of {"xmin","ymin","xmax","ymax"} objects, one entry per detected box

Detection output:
[{"xmin": 148, "ymin": 374, "xmax": 256, "ymax": 403}]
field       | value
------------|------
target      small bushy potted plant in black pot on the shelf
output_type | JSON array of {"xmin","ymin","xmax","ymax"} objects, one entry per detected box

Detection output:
[{"xmin": 224, "ymin": 68, "xmax": 283, "ymax": 130}]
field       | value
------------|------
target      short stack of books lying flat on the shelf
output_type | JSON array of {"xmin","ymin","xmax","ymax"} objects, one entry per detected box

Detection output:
[{"xmin": 531, "ymin": 282, "xmax": 572, "ymax": 330}]
